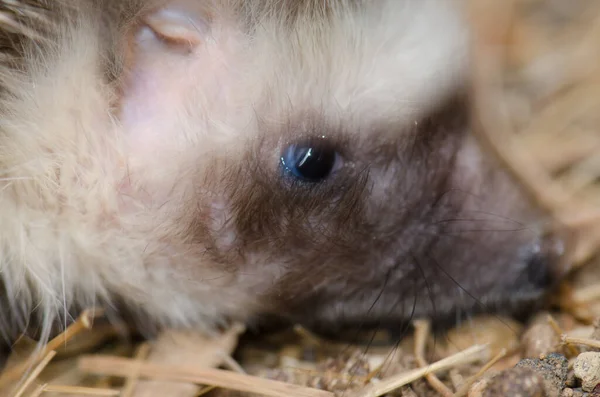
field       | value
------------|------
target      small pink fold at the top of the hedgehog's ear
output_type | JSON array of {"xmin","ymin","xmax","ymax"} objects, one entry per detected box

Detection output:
[{"xmin": 145, "ymin": 1, "xmax": 209, "ymax": 47}]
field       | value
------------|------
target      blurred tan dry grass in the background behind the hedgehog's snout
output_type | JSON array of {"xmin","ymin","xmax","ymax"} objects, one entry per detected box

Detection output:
[{"xmin": 469, "ymin": 0, "xmax": 600, "ymax": 264}]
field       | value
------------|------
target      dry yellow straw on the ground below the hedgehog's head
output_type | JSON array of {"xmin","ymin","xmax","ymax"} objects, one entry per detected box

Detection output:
[{"xmin": 3, "ymin": 313, "xmax": 496, "ymax": 397}]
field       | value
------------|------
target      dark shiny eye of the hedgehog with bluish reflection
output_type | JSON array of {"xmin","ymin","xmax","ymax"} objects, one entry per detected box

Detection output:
[{"xmin": 281, "ymin": 145, "xmax": 340, "ymax": 182}]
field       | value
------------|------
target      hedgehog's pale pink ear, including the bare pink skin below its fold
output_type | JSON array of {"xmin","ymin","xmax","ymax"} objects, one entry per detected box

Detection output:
[{"xmin": 119, "ymin": 0, "xmax": 230, "ymax": 165}]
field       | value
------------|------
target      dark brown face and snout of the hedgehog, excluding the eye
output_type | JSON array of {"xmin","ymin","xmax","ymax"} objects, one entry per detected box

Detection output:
[{"xmin": 186, "ymin": 96, "xmax": 560, "ymax": 331}]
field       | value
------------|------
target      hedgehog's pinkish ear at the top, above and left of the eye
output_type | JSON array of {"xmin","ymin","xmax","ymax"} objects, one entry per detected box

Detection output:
[{"xmin": 116, "ymin": 0, "xmax": 229, "ymax": 150}]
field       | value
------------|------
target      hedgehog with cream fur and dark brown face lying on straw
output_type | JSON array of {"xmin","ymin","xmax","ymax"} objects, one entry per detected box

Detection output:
[{"xmin": 0, "ymin": 0, "xmax": 566, "ymax": 352}]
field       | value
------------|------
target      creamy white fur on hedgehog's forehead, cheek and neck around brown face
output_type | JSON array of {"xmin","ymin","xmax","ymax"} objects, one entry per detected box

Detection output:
[{"xmin": 0, "ymin": 0, "xmax": 466, "ymax": 340}]
